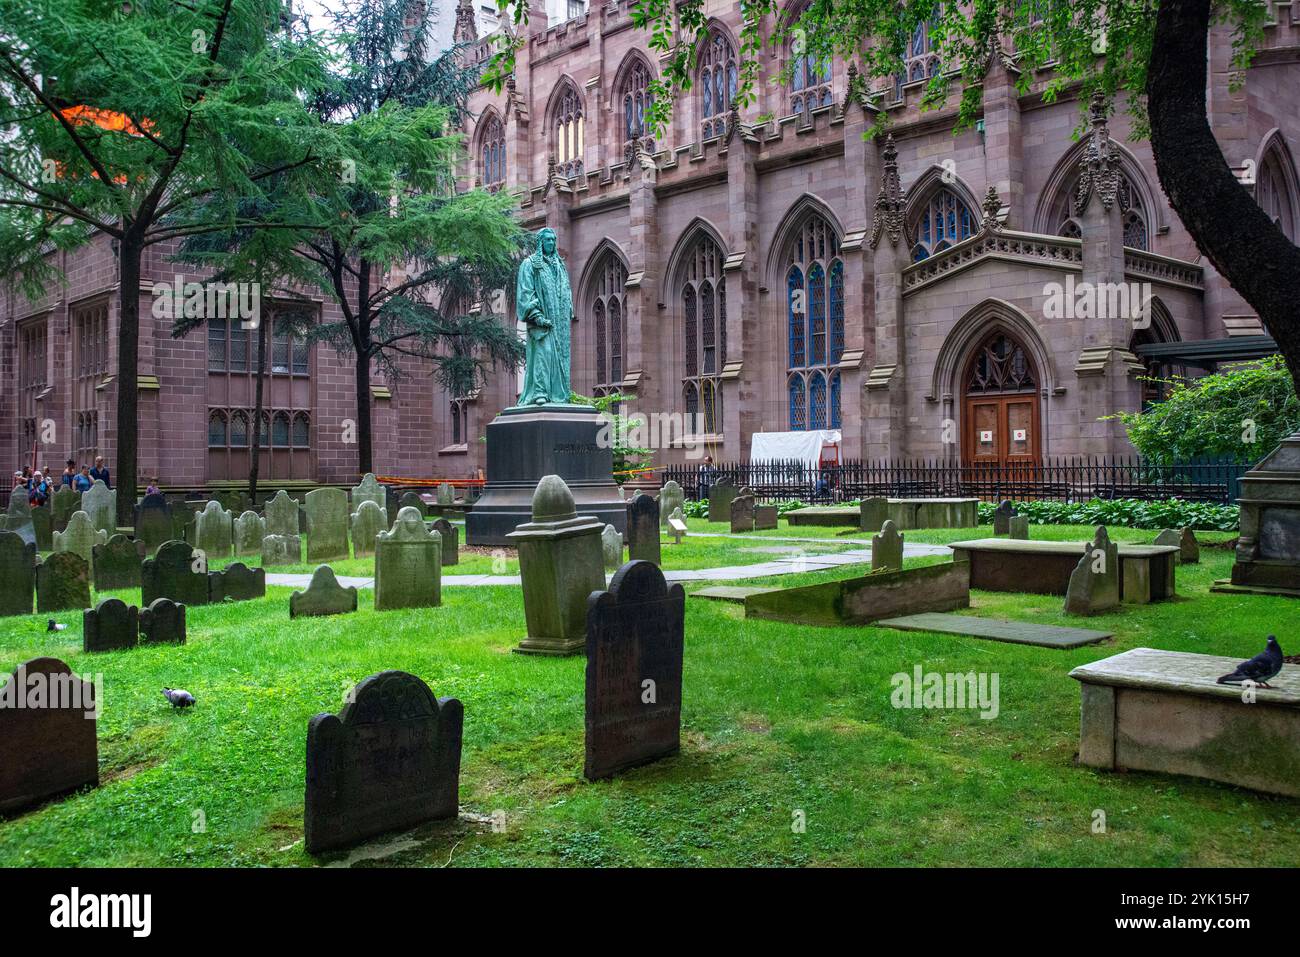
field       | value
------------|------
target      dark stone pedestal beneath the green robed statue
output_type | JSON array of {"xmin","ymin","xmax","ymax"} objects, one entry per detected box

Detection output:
[{"xmin": 465, "ymin": 406, "xmax": 627, "ymax": 548}]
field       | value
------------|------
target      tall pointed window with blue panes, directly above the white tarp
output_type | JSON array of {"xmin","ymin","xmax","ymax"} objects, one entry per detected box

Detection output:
[{"xmin": 785, "ymin": 215, "xmax": 844, "ymax": 430}]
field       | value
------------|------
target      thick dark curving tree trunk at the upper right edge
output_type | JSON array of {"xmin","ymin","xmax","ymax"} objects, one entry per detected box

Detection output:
[{"xmin": 1147, "ymin": 0, "xmax": 1300, "ymax": 387}]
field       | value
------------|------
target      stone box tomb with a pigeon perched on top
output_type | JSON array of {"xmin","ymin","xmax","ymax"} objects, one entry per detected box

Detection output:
[{"xmin": 1070, "ymin": 648, "xmax": 1300, "ymax": 797}]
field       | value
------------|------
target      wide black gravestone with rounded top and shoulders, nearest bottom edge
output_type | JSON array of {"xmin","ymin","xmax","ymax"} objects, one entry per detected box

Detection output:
[{"xmin": 303, "ymin": 671, "xmax": 464, "ymax": 854}]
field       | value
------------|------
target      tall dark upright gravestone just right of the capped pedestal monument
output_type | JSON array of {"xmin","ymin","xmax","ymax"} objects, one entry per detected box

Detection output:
[{"xmin": 582, "ymin": 562, "xmax": 686, "ymax": 780}]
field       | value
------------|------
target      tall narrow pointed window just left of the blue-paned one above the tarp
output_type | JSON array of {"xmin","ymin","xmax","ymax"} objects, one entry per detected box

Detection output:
[{"xmin": 677, "ymin": 234, "xmax": 727, "ymax": 434}]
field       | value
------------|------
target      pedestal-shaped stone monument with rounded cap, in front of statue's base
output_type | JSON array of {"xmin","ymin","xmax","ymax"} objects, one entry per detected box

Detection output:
[{"xmin": 506, "ymin": 475, "xmax": 608, "ymax": 654}]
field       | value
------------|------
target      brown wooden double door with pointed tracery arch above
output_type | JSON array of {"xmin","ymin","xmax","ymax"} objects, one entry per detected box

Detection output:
[{"xmin": 962, "ymin": 330, "xmax": 1041, "ymax": 465}]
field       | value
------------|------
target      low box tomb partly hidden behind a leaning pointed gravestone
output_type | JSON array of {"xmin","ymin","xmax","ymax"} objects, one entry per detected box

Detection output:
[{"xmin": 948, "ymin": 538, "xmax": 1179, "ymax": 605}]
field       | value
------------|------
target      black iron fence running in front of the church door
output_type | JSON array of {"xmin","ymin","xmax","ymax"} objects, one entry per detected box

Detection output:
[{"xmin": 660, "ymin": 456, "xmax": 1251, "ymax": 505}]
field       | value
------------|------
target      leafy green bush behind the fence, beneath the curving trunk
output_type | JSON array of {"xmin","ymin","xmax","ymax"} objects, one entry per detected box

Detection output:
[{"xmin": 1110, "ymin": 355, "xmax": 1300, "ymax": 462}]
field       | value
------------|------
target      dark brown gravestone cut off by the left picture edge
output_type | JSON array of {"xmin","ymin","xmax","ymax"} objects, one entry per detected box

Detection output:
[{"xmin": 0, "ymin": 657, "xmax": 99, "ymax": 814}]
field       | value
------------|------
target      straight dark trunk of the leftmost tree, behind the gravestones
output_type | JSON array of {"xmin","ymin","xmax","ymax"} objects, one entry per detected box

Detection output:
[{"xmin": 114, "ymin": 234, "xmax": 144, "ymax": 525}]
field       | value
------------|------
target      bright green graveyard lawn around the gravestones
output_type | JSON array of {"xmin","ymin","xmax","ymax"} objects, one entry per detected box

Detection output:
[{"xmin": 0, "ymin": 527, "xmax": 1300, "ymax": 867}]
